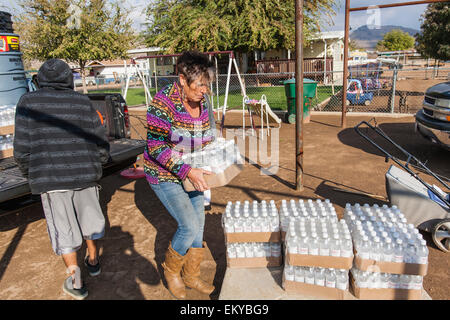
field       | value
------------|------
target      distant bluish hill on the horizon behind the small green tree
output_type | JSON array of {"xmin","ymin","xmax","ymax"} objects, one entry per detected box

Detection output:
[{"xmin": 350, "ymin": 26, "xmax": 420, "ymax": 49}]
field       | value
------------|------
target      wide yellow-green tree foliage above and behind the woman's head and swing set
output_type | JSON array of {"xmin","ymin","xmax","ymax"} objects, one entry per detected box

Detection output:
[{"xmin": 142, "ymin": 0, "xmax": 335, "ymax": 53}]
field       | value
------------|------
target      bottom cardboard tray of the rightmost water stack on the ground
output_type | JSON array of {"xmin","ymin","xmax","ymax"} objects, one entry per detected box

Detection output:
[{"xmin": 350, "ymin": 277, "xmax": 422, "ymax": 300}]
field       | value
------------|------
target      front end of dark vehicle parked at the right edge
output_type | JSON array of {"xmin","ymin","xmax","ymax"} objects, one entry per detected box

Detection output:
[{"xmin": 416, "ymin": 81, "xmax": 450, "ymax": 150}]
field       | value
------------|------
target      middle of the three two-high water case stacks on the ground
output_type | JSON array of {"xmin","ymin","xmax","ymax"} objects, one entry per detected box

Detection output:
[{"xmin": 280, "ymin": 200, "xmax": 353, "ymax": 300}]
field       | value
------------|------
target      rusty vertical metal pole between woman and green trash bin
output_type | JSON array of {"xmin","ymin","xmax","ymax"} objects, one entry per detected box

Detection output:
[{"xmin": 295, "ymin": 0, "xmax": 304, "ymax": 191}]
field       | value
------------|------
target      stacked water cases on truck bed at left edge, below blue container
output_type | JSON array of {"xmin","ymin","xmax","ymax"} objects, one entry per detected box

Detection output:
[{"xmin": 0, "ymin": 105, "xmax": 16, "ymax": 159}]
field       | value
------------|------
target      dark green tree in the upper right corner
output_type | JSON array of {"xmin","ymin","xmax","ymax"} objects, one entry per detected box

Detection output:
[{"xmin": 416, "ymin": 2, "xmax": 450, "ymax": 61}]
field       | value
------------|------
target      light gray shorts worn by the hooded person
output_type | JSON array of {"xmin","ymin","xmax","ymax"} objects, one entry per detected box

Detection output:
[{"xmin": 41, "ymin": 187, "xmax": 105, "ymax": 255}]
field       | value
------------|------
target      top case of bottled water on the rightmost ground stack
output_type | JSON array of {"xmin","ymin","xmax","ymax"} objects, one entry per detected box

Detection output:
[{"xmin": 344, "ymin": 204, "xmax": 428, "ymax": 276}]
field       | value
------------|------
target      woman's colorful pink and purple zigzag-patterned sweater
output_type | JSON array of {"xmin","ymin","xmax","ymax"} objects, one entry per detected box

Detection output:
[{"xmin": 144, "ymin": 82, "xmax": 214, "ymax": 184}]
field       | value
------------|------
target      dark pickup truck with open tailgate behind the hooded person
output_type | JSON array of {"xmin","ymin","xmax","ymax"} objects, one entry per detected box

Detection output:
[{"xmin": 0, "ymin": 93, "xmax": 146, "ymax": 209}]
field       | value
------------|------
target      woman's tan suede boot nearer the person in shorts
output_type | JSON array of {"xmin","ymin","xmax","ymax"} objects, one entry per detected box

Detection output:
[{"xmin": 162, "ymin": 243, "xmax": 187, "ymax": 299}]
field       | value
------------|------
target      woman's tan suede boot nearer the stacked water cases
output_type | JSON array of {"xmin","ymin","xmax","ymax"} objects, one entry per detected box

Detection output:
[{"xmin": 181, "ymin": 245, "xmax": 214, "ymax": 294}]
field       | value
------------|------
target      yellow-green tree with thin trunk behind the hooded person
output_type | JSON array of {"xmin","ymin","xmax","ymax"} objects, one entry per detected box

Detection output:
[{"xmin": 16, "ymin": 0, "xmax": 135, "ymax": 93}]
